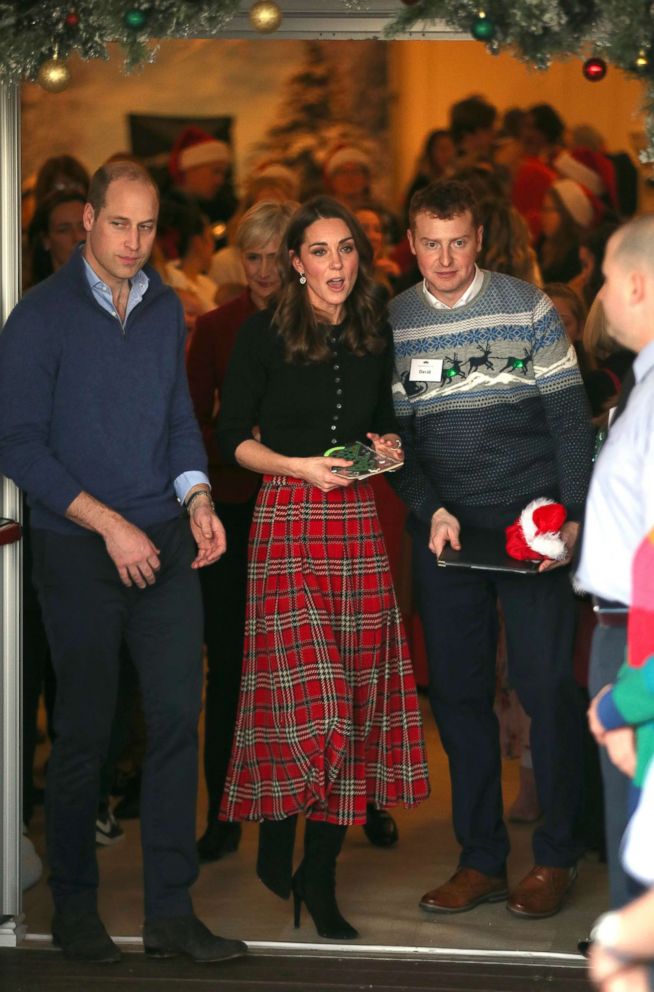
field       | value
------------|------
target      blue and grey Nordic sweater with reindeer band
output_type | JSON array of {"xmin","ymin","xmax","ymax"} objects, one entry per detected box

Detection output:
[{"xmin": 390, "ymin": 272, "xmax": 593, "ymax": 523}]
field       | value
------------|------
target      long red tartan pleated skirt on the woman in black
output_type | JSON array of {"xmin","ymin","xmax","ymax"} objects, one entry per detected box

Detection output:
[{"xmin": 221, "ymin": 476, "xmax": 429, "ymax": 824}]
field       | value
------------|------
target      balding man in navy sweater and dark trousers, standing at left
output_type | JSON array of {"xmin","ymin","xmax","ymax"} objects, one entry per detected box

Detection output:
[{"xmin": 0, "ymin": 162, "xmax": 245, "ymax": 961}]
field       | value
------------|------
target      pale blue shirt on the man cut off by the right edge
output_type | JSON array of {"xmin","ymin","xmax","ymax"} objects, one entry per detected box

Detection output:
[{"xmin": 577, "ymin": 341, "xmax": 654, "ymax": 606}]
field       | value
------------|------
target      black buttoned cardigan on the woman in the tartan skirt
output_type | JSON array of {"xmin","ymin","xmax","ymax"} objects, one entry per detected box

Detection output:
[{"xmin": 217, "ymin": 311, "xmax": 397, "ymax": 462}]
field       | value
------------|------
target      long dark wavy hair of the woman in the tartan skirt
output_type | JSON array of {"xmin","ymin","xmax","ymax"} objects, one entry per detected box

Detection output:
[{"xmin": 274, "ymin": 196, "xmax": 385, "ymax": 362}]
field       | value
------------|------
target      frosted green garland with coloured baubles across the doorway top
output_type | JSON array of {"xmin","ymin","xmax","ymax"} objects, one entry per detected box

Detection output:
[{"xmin": 0, "ymin": 0, "xmax": 654, "ymax": 153}]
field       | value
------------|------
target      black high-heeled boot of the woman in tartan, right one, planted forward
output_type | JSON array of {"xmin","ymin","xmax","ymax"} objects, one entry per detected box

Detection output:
[{"xmin": 293, "ymin": 820, "xmax": 359, "ymax": 940}]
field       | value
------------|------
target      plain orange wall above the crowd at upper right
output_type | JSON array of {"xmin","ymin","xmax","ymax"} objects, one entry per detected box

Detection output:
[{"xmin": 390, "ymin": 41, "xmax": 643, "ymax": 205}]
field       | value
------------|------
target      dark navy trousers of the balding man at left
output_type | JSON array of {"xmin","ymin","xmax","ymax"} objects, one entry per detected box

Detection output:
[{"xmin": 33, "ymin": 518, "xmax": 202, "ymax": 919}]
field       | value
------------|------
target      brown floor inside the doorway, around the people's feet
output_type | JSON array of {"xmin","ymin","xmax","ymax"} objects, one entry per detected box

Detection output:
[{"xmin": 24, "ymin": 692, "xmax": 606, "ymax": 963}]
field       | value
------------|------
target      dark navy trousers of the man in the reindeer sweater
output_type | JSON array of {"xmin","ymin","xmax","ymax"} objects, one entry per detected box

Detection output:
[{"xmin": 413, "ymin": 533, "xmax": 583, "ymax": 875}]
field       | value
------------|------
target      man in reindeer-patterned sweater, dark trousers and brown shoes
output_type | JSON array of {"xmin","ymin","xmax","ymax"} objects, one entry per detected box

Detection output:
[{"xmin": 391, "ymin": 181, "xmax": 592, "ymax": 918}]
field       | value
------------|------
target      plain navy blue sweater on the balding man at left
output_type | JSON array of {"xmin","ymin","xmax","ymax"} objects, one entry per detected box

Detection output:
[{"xmin": 0, "ymin": 252, "xmax": 206, "ymax": 534}]
